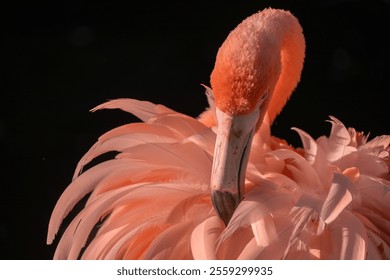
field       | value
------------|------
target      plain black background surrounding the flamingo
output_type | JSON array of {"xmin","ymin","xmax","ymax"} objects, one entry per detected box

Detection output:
[{"xmin": 0, "ymin": 0, "xmax": 390, "ymax": 259}]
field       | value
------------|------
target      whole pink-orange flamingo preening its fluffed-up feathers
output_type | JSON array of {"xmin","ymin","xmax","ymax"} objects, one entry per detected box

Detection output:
[{"xmin": 47, "ymin": 8, "xmax": 390, "ymax": 259}]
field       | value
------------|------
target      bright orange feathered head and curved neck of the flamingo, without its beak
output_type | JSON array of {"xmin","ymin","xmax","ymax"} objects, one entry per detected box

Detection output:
[{"xmin": 210, "ymin": 9, "xmax": 305, "ymax": 122}]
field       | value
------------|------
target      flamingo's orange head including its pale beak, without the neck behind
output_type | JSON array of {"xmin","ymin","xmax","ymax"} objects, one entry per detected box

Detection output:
[{"xmin": 210, "ymin": 9, "xmax": 281, "ymax": 225}]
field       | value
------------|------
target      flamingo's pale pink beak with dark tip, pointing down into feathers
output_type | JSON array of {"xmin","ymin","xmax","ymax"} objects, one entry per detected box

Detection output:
[{"xmin": 210, "ymin": 107, "xmax": 260, "ymax": 225}]
